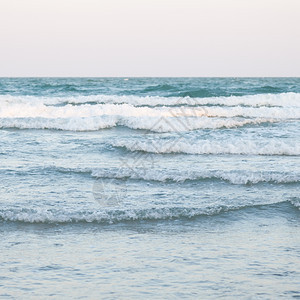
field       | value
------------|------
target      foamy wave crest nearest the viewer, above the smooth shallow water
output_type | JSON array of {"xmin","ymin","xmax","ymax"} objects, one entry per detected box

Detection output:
[{"xmin": 0, "ymin": 200, "xmax": 300, "ymax": 224}]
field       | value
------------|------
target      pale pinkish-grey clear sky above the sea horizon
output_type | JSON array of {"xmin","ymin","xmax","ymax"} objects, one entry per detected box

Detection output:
[{"xmin": 0, "ymin": 0, "xmax": 300, "ymax": 77}]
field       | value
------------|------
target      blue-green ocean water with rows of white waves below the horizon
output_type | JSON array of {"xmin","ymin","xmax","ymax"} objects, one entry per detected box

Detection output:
[{"xmin": 0, "ymin": 78, "xmax": 300, "ymax": 299}]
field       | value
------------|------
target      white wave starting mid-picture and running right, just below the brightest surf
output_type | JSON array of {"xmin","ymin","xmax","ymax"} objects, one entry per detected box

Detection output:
[{"xmin": 112, "ymin": 139, "xmax": 300, "ymax": 156}]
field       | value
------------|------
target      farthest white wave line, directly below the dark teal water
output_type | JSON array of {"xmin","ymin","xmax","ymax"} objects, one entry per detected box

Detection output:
[{"xmin": 0, "ymin": 92, "xmax": 300, "ymax": 107}]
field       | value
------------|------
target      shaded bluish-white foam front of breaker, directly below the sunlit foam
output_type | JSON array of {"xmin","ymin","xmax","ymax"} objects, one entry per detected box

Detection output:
[{"xmin": 0, "ymin": 115, "xmax": 276, "ymax": 132}]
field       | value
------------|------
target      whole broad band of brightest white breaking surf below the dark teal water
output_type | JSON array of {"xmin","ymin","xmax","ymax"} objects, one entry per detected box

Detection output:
[{"xmin": 0, "ymin": 93, "xmax": 300, "ymax": 132}]
